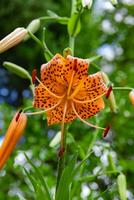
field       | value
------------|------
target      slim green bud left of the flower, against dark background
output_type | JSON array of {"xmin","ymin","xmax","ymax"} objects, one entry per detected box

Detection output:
[{"xmin": 3, "ymin": 62, "xmax": 31, "ymax": 80}]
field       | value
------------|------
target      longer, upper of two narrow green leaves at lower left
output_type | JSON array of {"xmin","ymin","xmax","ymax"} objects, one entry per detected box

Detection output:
[{"xmin": 25, "ymin": 154, "xmax": 52, "ymax": 200}]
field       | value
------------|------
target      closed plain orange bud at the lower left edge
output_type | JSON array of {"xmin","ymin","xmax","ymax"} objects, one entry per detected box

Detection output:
[{"xmin": 0, "ymin": 112, "xmax": 27, "ymax": 169}]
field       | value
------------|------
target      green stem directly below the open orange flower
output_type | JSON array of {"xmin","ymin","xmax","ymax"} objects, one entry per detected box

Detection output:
[{"xmin": 56, "ymin": 125, "xmax": 68, "ymax": 191}]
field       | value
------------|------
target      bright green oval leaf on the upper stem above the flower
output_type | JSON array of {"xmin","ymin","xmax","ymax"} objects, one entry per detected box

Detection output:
[{"xmin": 68, "ymin": 13, "xmax": 81, "ymax": 37}]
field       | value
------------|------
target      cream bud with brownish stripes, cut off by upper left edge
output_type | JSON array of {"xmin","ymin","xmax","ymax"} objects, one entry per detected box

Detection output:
[{"xmin": 0, "ymin": 28, "xmax": 28, "ymax": 53}]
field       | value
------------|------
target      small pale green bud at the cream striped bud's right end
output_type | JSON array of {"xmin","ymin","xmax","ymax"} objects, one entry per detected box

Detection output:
[{"xmin": 24, "ymin": 19, "xmax": 40, "ymax": 41}]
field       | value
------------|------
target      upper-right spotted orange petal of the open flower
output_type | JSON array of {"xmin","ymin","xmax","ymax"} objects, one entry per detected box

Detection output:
[{"xmin": 75, "ymin": 72, "xmax": 107, "ymax": 101}]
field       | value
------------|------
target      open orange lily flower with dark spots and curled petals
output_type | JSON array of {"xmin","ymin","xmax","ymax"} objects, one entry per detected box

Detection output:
[{"xmin": 32, "ymin": 54, "xmax": 107, "ymax": 148}]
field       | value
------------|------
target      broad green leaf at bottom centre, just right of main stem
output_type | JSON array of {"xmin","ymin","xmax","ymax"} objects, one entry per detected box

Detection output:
[{"xmin": 55, "ymin": 154, "xmax": 77, "ymax": 200}]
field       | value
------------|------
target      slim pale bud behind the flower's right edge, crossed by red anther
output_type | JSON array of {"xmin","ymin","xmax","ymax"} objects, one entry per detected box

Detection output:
[{"xmin": 101, "ymin": 72, "xmax": 117, "ymax": 113}]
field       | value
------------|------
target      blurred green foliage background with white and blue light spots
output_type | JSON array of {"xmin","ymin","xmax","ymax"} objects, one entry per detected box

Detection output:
[{"xmin": 0, "ymin": 0, "xmax": 134, "ymax": 200}]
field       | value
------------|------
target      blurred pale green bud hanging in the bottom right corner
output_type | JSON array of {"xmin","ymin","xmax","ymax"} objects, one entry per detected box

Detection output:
[{"xmin": 117, "ymin": 173, "xmax": 127, "ymax": 200}]
